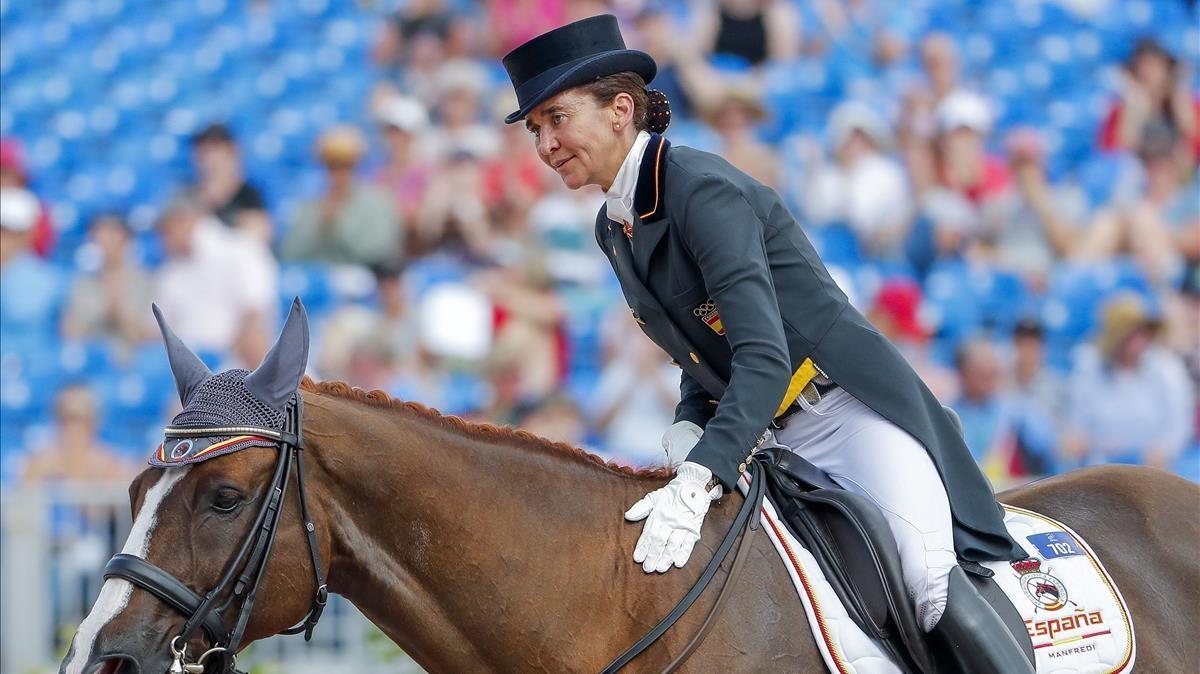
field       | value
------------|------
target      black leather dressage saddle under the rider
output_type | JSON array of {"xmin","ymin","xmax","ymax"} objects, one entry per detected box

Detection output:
[{"xmin": 760, "ymin": 447, "xmax": 1033, "ymax": 673}]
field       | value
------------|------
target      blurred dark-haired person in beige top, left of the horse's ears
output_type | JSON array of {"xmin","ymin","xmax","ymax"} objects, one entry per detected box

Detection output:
[{"xmin": 62, "ymin": 213, "xmax": 155, "ymax": 355}]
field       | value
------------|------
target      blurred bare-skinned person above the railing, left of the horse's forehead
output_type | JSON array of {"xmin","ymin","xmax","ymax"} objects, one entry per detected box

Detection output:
[{"xmin": 22, "ymin": 384, "xmax": 138, "ymax": 483}]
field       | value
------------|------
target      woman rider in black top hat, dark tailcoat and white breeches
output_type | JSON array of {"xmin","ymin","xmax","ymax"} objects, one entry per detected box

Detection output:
[{"xmin": 503, "ymin": 14, "xmax": 1032, "ymax": 673}]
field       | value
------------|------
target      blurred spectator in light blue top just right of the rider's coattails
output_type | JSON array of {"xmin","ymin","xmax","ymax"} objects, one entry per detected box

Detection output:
[{"xmin": 950, "ymin": 338, "xmax": 1015, "ymax": 483}]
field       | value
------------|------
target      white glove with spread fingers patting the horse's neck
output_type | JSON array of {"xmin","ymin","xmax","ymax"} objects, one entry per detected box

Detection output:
[{"xmin": 625, "ymin": 461, "xmax": 721, "ymax": 573}]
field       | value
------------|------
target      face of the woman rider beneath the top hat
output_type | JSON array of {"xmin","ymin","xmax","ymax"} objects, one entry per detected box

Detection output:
[{"xmin": 526, "ymin": 89, "xmax": 634, "ymax": 189}]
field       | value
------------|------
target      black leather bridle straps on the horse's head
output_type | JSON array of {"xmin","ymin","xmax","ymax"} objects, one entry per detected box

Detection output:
[{"xmin": 104, "ymin": 392, "xmax": 329, "ymax": 672}]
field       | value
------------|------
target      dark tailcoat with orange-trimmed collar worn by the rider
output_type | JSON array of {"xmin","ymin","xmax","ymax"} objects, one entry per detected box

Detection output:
[{"xmin": 596, "ymin": 134, "xmax": 1025, "ymax": 561}]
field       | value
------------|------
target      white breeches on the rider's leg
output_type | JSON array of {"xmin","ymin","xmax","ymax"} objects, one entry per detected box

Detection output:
[{"xmin": 763, "ymin": 389, "xmax": 958, "ymax": 632}]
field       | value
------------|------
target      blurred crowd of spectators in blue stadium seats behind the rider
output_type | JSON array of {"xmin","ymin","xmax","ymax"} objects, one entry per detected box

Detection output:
[{"xmin": 0, "ymin": 0, "xmax": 1200, "ymax": 485}]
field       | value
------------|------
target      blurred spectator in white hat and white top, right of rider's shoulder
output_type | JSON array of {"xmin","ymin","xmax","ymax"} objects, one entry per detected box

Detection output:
[{"xmin": 802, "ymin": 102, "xmax": 913, "ymax": 259}]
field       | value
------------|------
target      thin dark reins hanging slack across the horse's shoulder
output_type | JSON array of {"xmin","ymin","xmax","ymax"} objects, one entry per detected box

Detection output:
[{"xmin": 600, "ymin": 452, "xmax": 767, "ymax": 674}]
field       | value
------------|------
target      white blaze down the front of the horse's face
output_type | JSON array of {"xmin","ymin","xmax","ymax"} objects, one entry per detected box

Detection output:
[{"xmin": 62, "ymin": 465, "xmax": 191, "ymax": 674}]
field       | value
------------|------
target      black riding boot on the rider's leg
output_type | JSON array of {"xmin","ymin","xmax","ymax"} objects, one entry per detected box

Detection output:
[{"xmin": 929, "ymin": 566, "xmax": 1033, "ymax": 674}]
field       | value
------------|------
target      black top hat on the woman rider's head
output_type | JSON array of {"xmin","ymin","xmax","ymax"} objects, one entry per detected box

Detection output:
[{"xmin": 504, "ymin": 14, "xmax": 658, "ymax": 124}]
